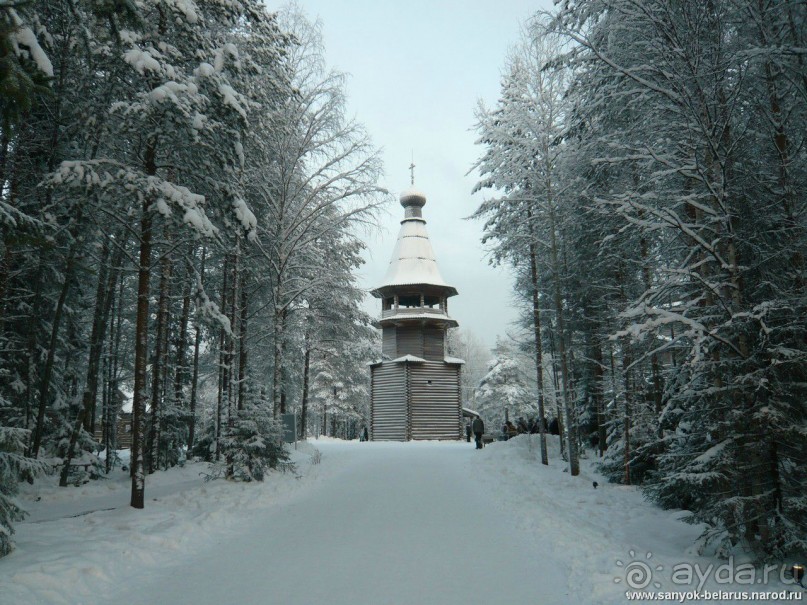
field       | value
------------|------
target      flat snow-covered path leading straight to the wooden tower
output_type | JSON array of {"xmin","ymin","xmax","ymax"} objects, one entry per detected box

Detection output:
[{"xmin": 104, "ymin": 442, "xmax": 569, "ymax": 605}]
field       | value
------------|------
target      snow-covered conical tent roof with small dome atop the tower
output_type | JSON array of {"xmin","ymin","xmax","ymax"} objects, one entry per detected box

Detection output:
[{"xmin": 379, "ymin": 190, "xmax": 456, "ymax": 293}]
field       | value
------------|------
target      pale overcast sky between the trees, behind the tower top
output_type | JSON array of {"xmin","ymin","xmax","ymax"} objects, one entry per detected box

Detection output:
[{"xmin": 267, "ymin": 0, "xmax": 551, "ymax": 346}]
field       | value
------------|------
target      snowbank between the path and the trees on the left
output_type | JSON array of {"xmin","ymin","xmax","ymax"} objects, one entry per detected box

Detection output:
[{"xmin": 0, "ymin": 443, "xmax": 325, "ymax": 605}]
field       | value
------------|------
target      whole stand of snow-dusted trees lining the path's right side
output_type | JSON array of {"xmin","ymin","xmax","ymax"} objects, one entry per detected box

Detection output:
[{"xmin": 477, "ymin": 0, "xmax": 807, "ymax": 556}]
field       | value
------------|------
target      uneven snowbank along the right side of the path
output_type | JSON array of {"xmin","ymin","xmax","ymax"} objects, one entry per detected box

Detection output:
[{"xmin": 475, "ymin": 435, "xmax": 807, "ymax": 604}]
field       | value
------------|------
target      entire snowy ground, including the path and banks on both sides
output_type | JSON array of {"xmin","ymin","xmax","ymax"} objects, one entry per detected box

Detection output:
[{"xmin": 0, "ymin": 436, "xmax": 804, "ymax": 605}]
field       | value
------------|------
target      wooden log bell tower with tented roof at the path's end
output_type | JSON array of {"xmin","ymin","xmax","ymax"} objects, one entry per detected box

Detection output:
[{"xmin": 370, "ymin": 189, "xmax": 464, "ymax": 441}]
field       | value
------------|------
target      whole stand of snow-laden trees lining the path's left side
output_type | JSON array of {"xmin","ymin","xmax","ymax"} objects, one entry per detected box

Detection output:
[{"xmin": 0, "ymin": 0, "xmax": 383, "ymax": 552}]
